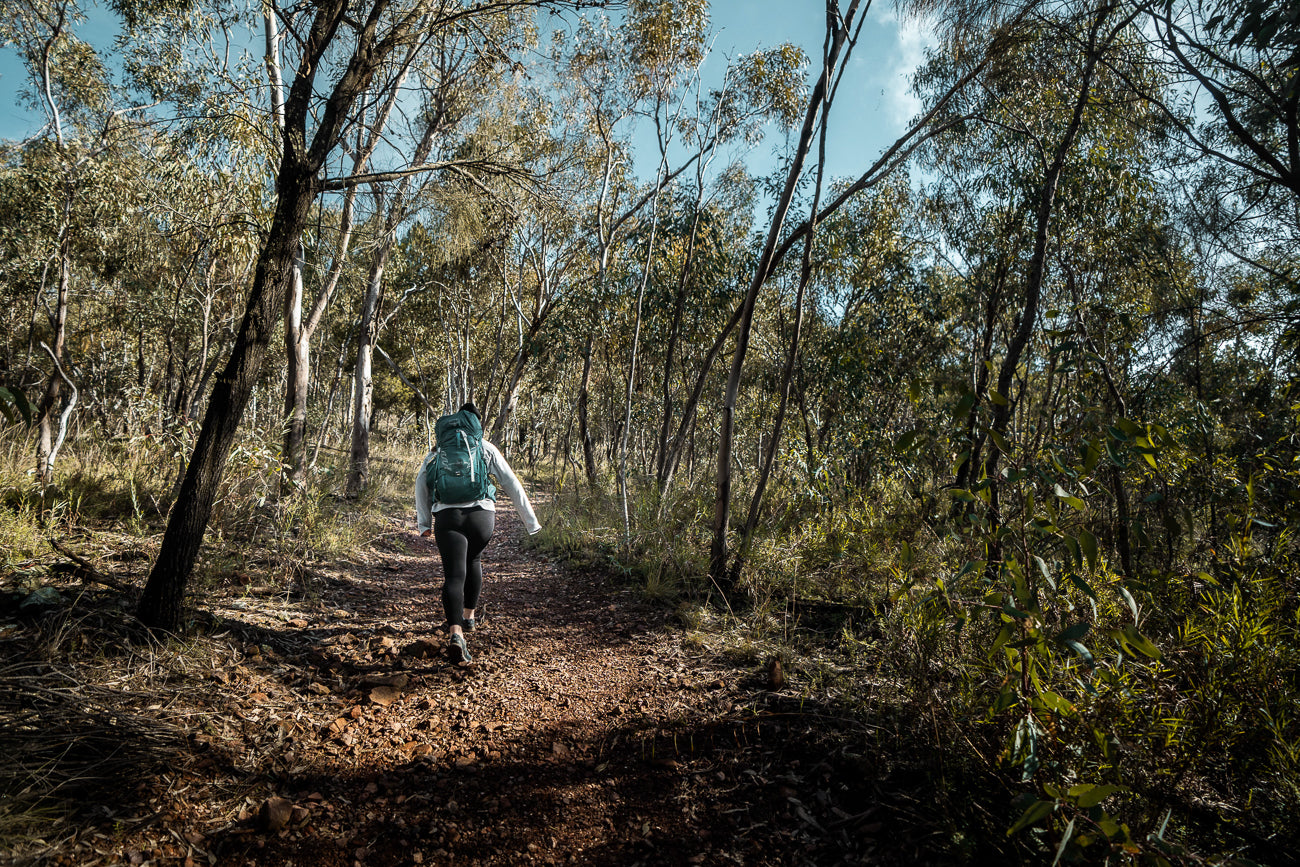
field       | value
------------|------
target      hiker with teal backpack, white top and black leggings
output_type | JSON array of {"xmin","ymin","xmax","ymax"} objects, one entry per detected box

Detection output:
[{"xmin": 415, "ymin": 403, "xmax": 542, "ymax": 663}]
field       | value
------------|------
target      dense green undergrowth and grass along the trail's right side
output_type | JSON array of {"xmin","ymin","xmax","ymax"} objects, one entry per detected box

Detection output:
[{"xmin": 551, "ymin": 452, "xmax": 1300, "ymax": 864}]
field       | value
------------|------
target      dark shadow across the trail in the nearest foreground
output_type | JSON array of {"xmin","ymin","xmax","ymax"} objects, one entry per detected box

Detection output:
[{"xmin": 212, "ymin": 696, "xmax": 1008, "ymax": 866}]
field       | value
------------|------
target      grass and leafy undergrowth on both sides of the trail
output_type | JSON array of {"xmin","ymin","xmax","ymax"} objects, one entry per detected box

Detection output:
[{"xmin": 0, "ymin": 423, "xmax": 1300, "ymax": 864}]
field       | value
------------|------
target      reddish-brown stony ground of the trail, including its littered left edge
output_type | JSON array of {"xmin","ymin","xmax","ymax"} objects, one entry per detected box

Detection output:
[{"xmin": 0, "ymin": 511, "xmax": 920, "ymax": 867}]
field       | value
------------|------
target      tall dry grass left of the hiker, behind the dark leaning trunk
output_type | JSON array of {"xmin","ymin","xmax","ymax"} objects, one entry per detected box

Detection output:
[{"xmin": 0, "ymin": 418, "xmax": 417, "ymax": 593}]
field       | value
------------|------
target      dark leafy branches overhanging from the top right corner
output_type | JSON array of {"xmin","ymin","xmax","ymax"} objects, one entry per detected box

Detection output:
[{"xmin": 1134, "ymin": 0, "xmax": 1300, "ymax": 470}]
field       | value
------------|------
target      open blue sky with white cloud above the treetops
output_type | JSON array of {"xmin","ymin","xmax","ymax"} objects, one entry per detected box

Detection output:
[{"xmin": 0, "ymin": 0, "xmax": 927, "ymax": 177}]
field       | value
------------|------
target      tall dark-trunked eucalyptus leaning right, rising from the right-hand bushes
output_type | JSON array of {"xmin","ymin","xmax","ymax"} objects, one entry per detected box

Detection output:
[{"xmin": 920, "ymin": 4, "xmax": 1185, "ymax": 590}]
